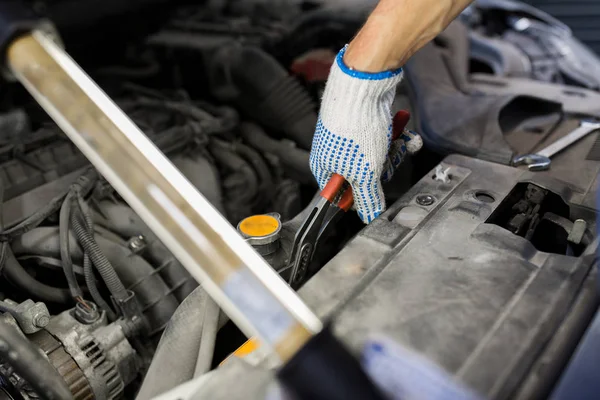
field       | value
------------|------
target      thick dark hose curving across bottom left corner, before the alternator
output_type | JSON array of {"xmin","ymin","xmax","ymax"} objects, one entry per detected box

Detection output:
[{"xmin": 0, "ymin": 318, "xmax": 73, "ymax": 400}]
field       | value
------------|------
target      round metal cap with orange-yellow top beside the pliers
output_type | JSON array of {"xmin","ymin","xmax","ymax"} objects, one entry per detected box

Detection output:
[{"xmin": 237, "ymin": 213, "xmax": 281, "ymax": 256}]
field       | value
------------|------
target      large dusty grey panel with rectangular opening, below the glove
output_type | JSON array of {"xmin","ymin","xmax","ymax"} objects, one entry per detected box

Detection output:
[{"xmin": 300, "ymin": 156, "xmax": 597, "ymax": 399}]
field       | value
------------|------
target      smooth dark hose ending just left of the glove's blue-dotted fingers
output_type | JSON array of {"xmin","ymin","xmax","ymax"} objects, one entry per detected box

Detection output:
[{"xmin": 240, "ymin": 122, "xmax": 316, "ymax": 186}]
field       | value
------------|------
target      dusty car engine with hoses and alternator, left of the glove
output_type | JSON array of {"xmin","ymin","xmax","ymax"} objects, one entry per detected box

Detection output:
[{"xmin": 0, "ymin": 1, "xmax": 360, "ymax": 399}]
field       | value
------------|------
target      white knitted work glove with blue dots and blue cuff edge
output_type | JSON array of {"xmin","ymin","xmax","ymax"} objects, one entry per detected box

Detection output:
[{"xmin": 310, "ymin": 48, "xmax": 423, "ymax": 224}]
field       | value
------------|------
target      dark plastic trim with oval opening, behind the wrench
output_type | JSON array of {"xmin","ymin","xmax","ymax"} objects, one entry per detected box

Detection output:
[{"xmin": 404, "ymin": 17, "xmax": 600, "ymax": 165}]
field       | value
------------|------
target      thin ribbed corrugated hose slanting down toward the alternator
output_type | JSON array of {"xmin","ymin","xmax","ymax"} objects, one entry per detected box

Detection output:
[{"xmin": 71, "ymin": 214, "xmax": 129, "ymax": 301}]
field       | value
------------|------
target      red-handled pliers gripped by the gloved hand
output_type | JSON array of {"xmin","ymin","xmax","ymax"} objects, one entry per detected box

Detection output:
[{"xmin": 289, "ymin": 174, "xmax": 354, "ymax": 285}]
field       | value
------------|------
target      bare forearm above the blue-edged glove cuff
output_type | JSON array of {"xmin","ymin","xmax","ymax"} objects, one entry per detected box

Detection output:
[{"xmin": 344, "ymin": 0, "xmax": 473, "ymax": 72}]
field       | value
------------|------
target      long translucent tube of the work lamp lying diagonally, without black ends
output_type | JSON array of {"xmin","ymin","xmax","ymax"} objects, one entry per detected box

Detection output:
[{"xmin": 7, "ymin": 31, "xmax": 322, "ymax": 362}]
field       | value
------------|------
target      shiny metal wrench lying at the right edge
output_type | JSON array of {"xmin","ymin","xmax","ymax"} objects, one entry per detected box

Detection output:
[{"xmin": 513, "ymin": 120, "xmax": 600, "ymax": 171}]
